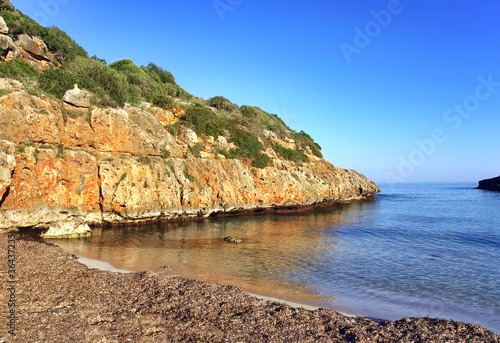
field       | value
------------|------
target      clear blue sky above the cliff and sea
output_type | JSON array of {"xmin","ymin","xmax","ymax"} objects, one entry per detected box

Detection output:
[{"xmin": 12, "ymin": 0, "xmax": 500, "ymax": 183}]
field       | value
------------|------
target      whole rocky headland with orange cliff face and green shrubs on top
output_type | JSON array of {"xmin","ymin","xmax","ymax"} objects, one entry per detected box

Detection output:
[{"xmin": 0, "ymin": 0, "xmax": 379, "ymax": 235}]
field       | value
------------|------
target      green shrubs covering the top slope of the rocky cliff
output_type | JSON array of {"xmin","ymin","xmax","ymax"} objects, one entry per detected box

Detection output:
[{"xmin": 0, "ymin": 0, "xmax": 322, "ymax": 168}]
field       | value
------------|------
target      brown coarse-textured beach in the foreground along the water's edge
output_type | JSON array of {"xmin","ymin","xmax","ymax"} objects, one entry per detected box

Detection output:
[{"xmin": 0, "ymin": 231, "xmax": 500, "ymax": 342}]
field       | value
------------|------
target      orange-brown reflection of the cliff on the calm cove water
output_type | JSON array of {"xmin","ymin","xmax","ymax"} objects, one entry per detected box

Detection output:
[{"xmin": 50, "ymin": 201, "xmax": 376, "ymax": 307}]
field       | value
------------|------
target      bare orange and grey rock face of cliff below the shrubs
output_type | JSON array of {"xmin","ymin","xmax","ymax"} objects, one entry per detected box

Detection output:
[{"xmin": 0, "ymin": 83, "xmax": 379, "ymax": 234}]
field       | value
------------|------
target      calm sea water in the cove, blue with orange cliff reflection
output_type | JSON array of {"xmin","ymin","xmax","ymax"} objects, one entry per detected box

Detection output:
[{"xmin": 49, "ymin": 183, "xmax": 500, "ymax": 333}]
